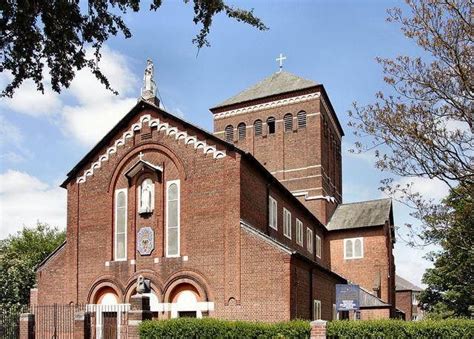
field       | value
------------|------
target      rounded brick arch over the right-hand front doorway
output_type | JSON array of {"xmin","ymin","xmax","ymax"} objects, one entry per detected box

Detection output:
[{"xmin": 163, "ymin": 270, "xmax": 213, "ymax": 303}]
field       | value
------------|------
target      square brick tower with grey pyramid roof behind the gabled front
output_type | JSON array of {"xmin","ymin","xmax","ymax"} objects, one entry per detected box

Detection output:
[{"xmin": 210, "ymin": 71, "xmax": 344, "ymax": 224}]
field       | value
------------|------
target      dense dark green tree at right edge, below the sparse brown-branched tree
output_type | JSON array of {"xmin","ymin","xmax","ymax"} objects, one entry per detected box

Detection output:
[{"xmin": 420, "ymin": 184, "xmax": 474, "ymax": 318}]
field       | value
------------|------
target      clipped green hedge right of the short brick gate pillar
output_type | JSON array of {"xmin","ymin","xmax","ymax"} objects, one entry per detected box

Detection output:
[{"xmin": 327, "ymin": 319, "xmax": 474, "ymax": 339}]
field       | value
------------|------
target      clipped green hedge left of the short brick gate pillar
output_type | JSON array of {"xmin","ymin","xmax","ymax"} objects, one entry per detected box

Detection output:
[{"xmin": 140, "ymin": 318, "xmax": 310, "ymax": 339}]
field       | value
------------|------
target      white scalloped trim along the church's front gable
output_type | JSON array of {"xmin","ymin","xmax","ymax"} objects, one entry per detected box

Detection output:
[{"xmin": 76, "ymin": 114, "xmax": 226, "ymax": 184}]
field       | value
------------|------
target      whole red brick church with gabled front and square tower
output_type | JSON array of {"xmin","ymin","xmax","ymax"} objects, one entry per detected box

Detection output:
[{"xmin": 32, "ymin": 62, "xmax": 395, "ymax": 322}]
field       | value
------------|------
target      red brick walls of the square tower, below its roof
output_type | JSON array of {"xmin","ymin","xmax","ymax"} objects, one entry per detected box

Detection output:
[{"xmin": 214, "ymin": 89, "xmax": 342, "ymax": 224}]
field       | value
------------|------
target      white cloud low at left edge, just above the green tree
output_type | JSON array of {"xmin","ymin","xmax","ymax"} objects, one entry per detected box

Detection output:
[{"xmin": 0, "ymin": 170, "xmax": 66, "ymax": 239}]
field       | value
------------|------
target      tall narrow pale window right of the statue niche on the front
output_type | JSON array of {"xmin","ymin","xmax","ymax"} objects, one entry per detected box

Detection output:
[{"xmin": 166, "ymin": 180, "xmax": 180, "ymax": 257}]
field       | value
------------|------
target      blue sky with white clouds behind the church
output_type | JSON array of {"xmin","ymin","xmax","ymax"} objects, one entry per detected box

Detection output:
[{"xmin": 0, "ymin": 0, "xmax": 446, "ymax": 284}]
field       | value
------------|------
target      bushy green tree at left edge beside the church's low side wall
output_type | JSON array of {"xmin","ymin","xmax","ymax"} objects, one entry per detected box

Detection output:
[{"xmin": 0, "ymin": 222, "xmax": 66, "ymax": 309}]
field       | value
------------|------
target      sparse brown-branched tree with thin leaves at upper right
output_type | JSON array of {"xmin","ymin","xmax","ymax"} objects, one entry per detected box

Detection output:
[{"xmin": 349, "ymin": 0, "xmax": 474, "ymax": 245}]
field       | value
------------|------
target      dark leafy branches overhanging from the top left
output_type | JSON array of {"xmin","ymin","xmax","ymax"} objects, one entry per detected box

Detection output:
[{"xmin": 0, "ymin": 0, "xmax": 267, "ymax": 96}]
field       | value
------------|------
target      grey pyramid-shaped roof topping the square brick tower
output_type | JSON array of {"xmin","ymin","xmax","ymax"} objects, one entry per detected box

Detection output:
[{"xmin": 214, "ymin": 71, "xmax": 318, "ymax": 108}]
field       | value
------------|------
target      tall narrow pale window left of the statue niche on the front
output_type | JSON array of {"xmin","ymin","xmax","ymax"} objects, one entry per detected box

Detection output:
[{"xmin": 114, "ymin": 188, "xmax": 127, "ymax": 261}]
